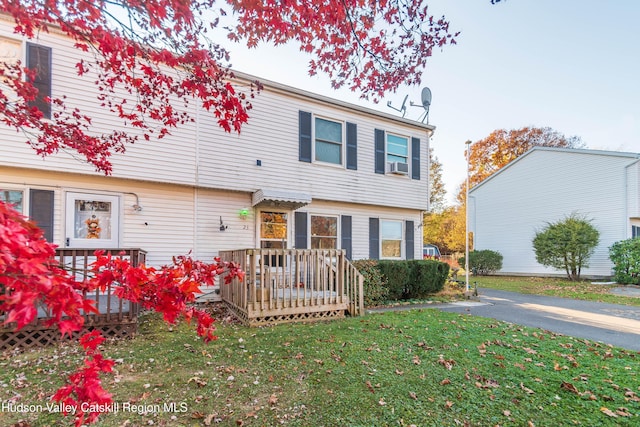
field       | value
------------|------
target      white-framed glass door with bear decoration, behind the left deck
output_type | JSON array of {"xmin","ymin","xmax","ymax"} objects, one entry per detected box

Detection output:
[{"xmin": 66, "ymin": 193, "xmax": 120, "ymax": 248}]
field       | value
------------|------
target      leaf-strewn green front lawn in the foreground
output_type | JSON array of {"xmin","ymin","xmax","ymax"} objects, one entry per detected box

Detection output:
[{"xmin": 0, "ymin": 310, "xmax": 640, "ymax": 427}]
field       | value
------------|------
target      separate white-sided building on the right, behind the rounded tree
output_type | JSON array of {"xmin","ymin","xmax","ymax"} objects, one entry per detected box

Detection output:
[{"xmin": 469, "ymin": 147, "xmax": 640, "ymax": 277}]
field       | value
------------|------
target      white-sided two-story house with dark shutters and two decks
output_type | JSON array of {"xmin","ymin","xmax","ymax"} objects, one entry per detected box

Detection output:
[{"xmin": 0, "ymin": 17, "xmax": 434, "ymax": 265}]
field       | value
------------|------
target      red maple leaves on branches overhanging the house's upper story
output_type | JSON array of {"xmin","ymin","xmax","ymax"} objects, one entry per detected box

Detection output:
[{"xmin": 0, "ymin": 0, "xmax": 455, "ymax": 174}]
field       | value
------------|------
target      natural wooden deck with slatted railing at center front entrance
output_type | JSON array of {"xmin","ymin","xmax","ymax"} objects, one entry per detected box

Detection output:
[{"xmin": 219, "ymin": 249, "xmax": 364, "ymax": 326}]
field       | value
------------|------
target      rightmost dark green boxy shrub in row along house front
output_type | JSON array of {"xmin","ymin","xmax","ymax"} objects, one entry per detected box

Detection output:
[{"xmin": 406, "ymin": 259, "xmax": 449, "ymax": 298}]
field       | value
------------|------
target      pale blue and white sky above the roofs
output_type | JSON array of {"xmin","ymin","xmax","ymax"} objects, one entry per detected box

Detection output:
[{"xmin": 221, "ymin": 0, "xmax": 640, "ymax": 204}]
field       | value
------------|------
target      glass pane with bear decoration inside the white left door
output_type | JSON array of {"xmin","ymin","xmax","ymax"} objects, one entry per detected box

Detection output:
[{"xmin": 73, "ymin": 200, "xmax": 111, "ymax": 239}]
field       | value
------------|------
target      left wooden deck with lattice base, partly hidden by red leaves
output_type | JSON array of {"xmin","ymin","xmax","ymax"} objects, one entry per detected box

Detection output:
[{"xmin": 0, "ymin": 248, "xmax": 146, "ymax": 351}]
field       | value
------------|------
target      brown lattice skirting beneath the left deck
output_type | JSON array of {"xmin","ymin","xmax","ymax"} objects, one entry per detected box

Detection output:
[{"xmin": 0, "ymin": 319, "xmax": 138, "ymax": 351}]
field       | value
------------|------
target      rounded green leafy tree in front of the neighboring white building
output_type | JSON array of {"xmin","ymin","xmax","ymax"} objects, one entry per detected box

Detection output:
[{"xmin": 533, "ymin": 213, "xmax": 600, "ymax": 280}]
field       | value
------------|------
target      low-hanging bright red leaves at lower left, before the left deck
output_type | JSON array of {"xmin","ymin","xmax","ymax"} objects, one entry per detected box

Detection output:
[{"xmin": 0, "ymin": 202, "xmax": 244, "ymax": 426}]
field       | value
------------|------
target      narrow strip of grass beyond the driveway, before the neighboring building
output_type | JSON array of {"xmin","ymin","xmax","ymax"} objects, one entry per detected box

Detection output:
[{"xmin": 469, "ymin": 276, "xmax": 640, "ymax": 306}]
